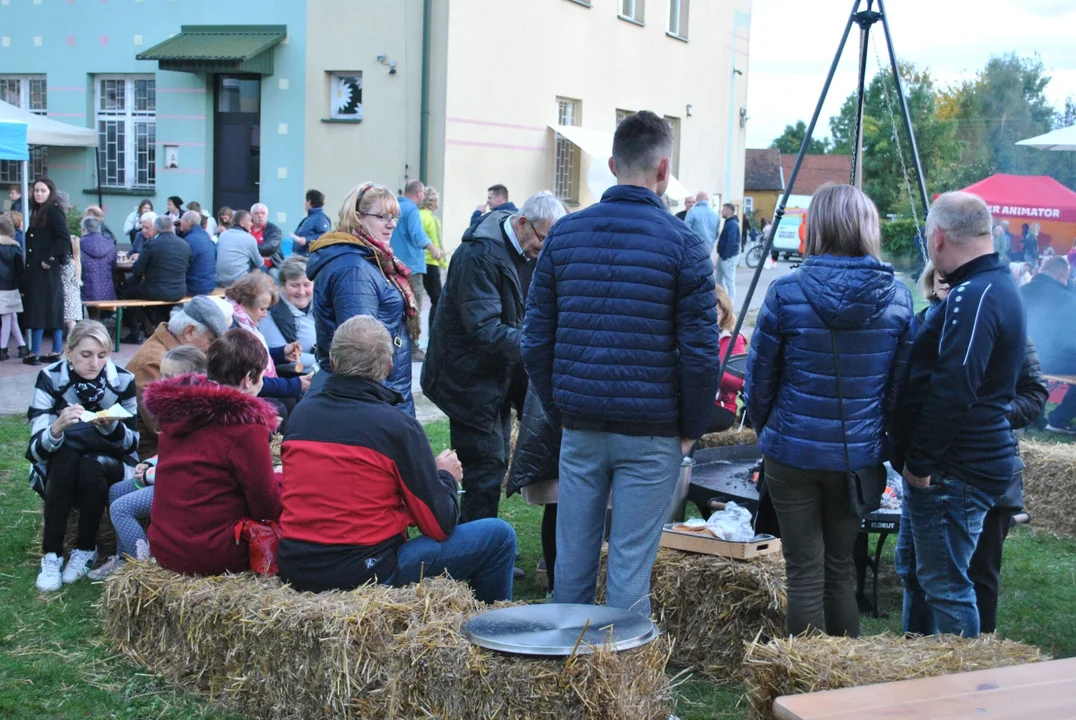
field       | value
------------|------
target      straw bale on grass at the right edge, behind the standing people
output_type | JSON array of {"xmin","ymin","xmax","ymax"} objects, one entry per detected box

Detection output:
[{"xmin": 1020, "ymin": 440, "xmax": 1076, "ymax": 537}]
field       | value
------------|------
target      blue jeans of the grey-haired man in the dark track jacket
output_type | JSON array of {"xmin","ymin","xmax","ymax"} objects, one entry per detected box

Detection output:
[{"xmin": 894, "ymin": 476, "xmax": 1000, "ymax": 637}]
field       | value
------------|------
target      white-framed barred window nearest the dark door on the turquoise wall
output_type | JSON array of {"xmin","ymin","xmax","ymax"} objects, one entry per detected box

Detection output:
[{"xmin": 94, "ymin": 75, "xmax": 157, "ymax": 189}]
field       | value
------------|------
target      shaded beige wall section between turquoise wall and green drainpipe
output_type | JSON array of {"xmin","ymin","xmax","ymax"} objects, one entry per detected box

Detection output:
[{"xmin": 303, "ymin": 0, "xmax": 428, "ymax": 220}]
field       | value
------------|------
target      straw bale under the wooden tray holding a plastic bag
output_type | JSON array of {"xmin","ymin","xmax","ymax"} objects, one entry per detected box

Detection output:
[{"xmin": 598, "ymin": 548, "xmax": 788, "ymax": 681}]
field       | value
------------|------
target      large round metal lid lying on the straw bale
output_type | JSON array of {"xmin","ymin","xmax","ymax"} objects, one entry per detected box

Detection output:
[{"xmin": 463, "ymin": 603, "xmax": 657, "ymax": 657}]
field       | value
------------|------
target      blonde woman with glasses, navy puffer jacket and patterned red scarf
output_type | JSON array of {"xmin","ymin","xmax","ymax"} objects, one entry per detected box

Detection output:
[{"xmin": 307, "ymin": 183, "xmax": 419, "ymax": 415}]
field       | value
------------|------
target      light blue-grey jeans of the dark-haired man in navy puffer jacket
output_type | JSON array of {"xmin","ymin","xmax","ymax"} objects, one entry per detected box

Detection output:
[{"xmin": 553, "ymin": 428, "xmax": 683, "ymax": 616}]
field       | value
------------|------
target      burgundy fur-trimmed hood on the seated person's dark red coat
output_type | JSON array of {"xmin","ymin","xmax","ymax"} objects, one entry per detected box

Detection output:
[{"xmin": 142, "ymin": 375, "xmax": 278, "ymax": 435}]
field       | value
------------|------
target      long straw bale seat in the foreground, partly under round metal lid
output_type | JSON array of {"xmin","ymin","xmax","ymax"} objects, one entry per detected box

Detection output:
[{"xmin": 103, "ymin": 562, "xmax": 670, "ymax": 718}]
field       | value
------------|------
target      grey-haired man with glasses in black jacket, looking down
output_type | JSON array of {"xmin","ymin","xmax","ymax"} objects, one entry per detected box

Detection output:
[{"xmin": 422, "ymin": 192, "xmax": 565, "ymax": 522}]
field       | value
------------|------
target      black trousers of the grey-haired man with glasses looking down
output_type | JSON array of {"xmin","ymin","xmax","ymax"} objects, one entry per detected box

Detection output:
[{"xmin": 449, "ymin": 400, "xmax": 512, "ymax": 523}]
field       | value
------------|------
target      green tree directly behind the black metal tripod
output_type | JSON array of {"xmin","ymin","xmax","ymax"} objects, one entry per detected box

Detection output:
[{"xmin": 830, "ymin": 62, "xmax": 961, "ymax": 218}]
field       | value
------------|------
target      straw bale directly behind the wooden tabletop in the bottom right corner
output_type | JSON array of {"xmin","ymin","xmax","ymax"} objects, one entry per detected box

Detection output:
[{"xmin": 744, "ymin": 634, "xmax": 1049, "ymax": 720}]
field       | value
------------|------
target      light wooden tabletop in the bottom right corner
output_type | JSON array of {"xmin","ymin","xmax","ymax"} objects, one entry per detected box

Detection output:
[{"xmin": 774, "ymin": 658, "xmax": 1076, "ymax": 720}]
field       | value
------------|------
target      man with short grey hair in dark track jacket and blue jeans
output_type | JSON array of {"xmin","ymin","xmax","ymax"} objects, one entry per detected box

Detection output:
[{"xmin": 893, "ymin": 193, "xmax": 1027, "ymax": 637}]
